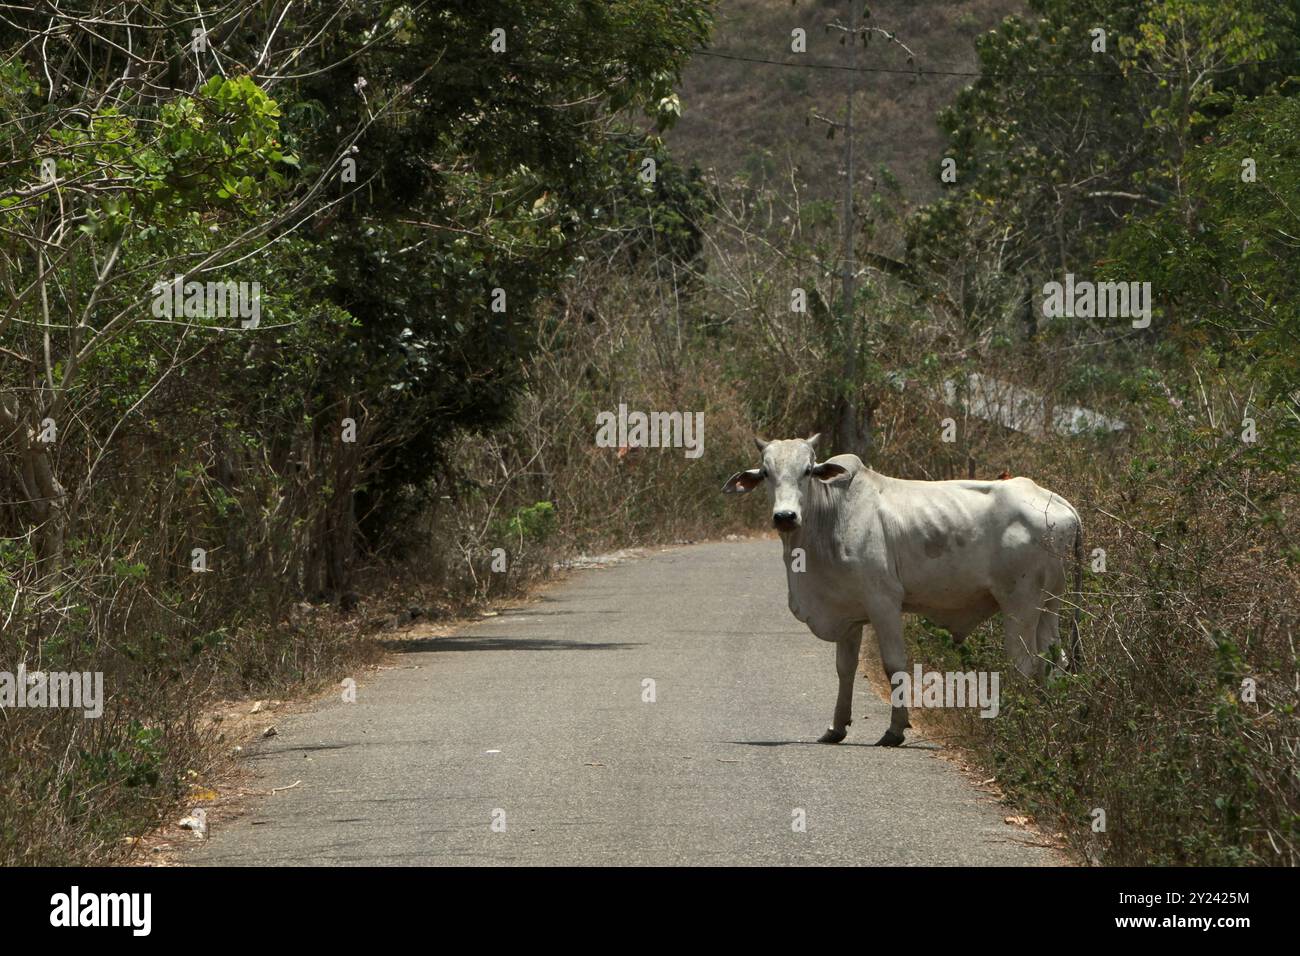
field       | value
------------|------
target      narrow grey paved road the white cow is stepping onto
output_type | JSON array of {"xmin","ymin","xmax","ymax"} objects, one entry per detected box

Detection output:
[{"xmin": 190, "ymin": 541, "xmax": 1061, "ymax": 865}]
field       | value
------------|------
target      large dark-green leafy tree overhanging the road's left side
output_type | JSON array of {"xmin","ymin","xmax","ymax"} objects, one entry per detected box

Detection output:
[{"xmin": 274, "ymin": 0, "xmax": 710, "ymax": 591}]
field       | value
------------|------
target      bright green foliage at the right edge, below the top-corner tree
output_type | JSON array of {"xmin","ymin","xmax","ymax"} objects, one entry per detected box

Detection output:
[{"xmin": 1108, "ymin": 95, "xmax": 1300, "ymax": 467}]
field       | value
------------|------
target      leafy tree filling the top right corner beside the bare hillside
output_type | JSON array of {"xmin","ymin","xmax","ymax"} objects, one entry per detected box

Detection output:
[{"xmin": 909, "ymin": 0, "xmax": 1300, "ymax": 332}]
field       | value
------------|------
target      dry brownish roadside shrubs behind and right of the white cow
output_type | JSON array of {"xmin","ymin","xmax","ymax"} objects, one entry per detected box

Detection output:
[{"xmin": 873, "ymin": 369, "xmax": 1300, "ymax": 865}]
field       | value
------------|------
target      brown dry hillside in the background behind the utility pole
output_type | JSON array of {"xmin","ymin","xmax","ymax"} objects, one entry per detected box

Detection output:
[{"xmin": 670, "ymin": 0, "xmax": 1024, "ymax": 202}]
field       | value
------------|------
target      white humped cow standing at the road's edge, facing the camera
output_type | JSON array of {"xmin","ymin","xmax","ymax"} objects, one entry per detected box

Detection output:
[{"xmin": 723, "ymin": 434, "xmax": 1083, "ymax": 747}]
